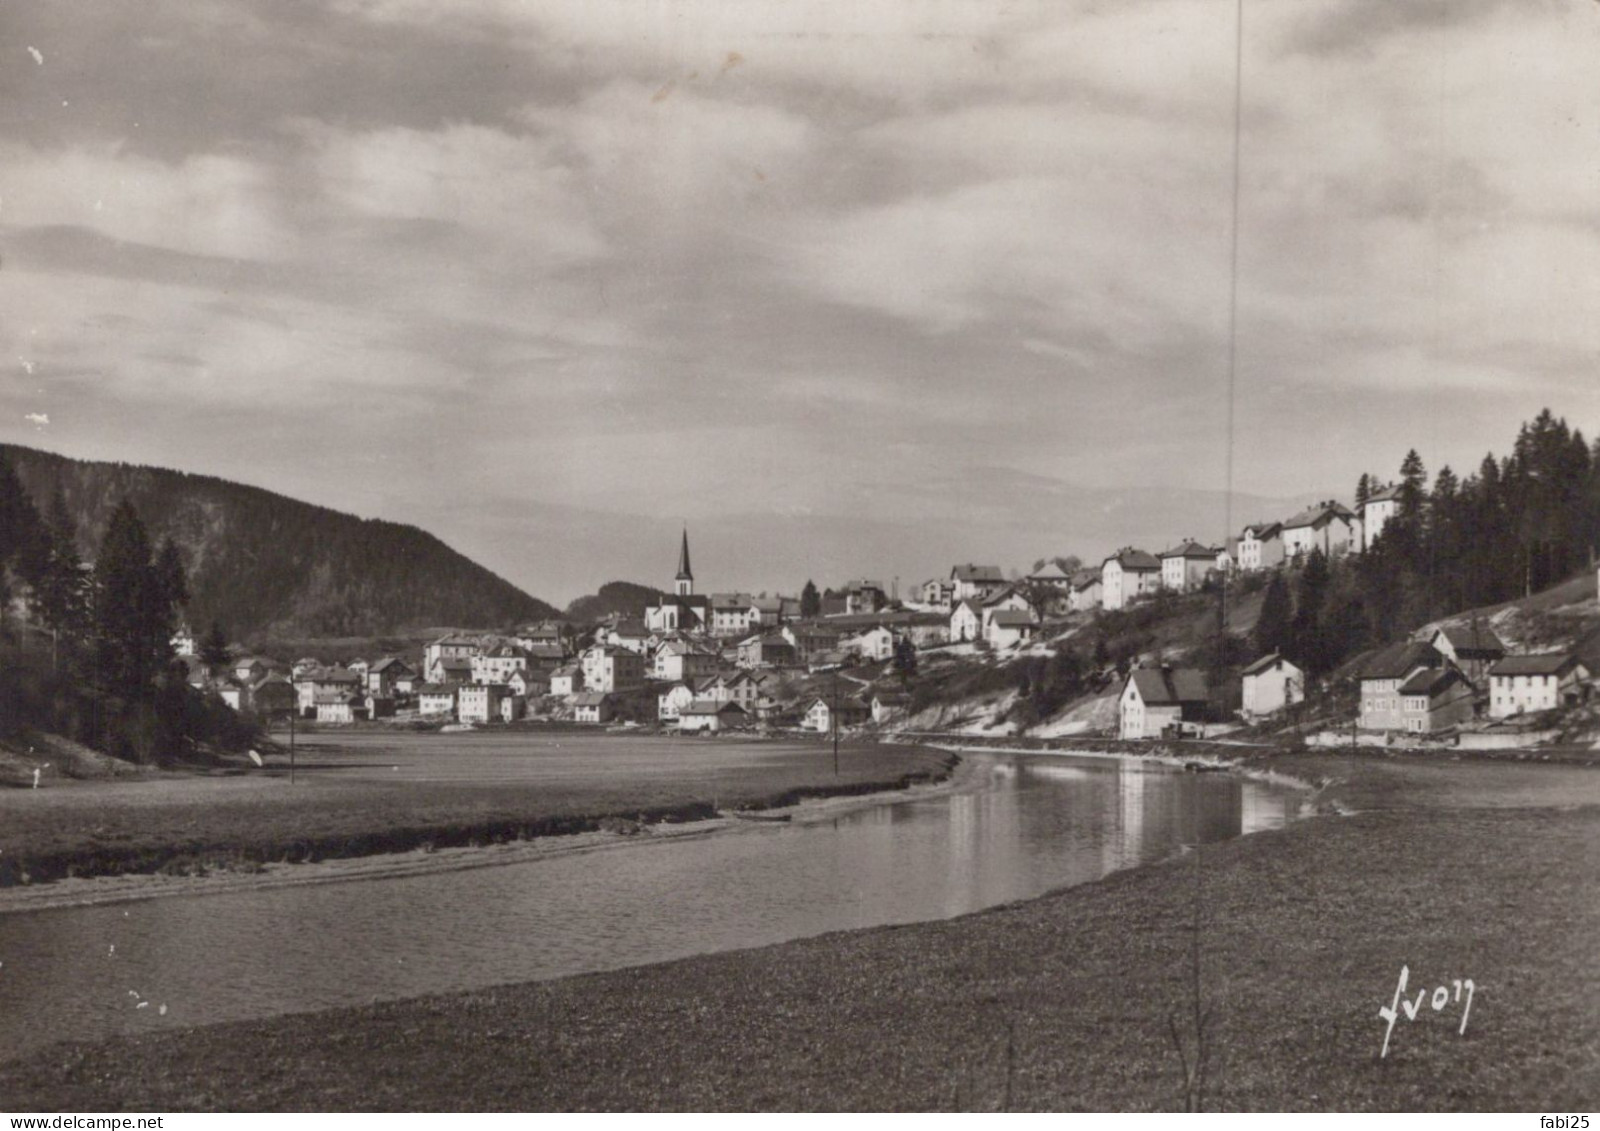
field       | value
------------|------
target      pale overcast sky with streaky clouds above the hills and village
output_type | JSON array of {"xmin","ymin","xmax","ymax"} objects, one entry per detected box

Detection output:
[{"xmin": 0, "ymin": 0, "xmax": 1600, "ymax": 601}]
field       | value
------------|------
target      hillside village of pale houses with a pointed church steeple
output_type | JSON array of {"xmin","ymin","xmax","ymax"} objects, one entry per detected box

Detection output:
[{"xmin": 173, "ymin": 485, "xmax": 1594, "ymax": 747}]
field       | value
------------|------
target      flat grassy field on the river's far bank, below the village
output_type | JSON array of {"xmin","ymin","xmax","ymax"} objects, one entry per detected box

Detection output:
[{"xmin": 0, "ymin": 729, "xmax": 949, "ymax": 883}]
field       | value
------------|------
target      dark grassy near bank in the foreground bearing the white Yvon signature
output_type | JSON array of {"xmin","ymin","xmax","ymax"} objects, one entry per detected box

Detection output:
[{"xmin": 0, "ymin": 758, "xmax": 1600, "ymax": 1112}]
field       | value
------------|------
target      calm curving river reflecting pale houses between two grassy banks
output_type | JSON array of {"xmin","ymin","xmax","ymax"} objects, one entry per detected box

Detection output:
[{"xmin": 0, "ymin": 755, "xmax": 1301, "ymax": 1057}]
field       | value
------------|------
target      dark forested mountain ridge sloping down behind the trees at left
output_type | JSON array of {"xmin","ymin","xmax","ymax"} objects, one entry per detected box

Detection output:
[{"xmin": 0, "ymin": 445, "xmax": 557, "ymax": 640}]
